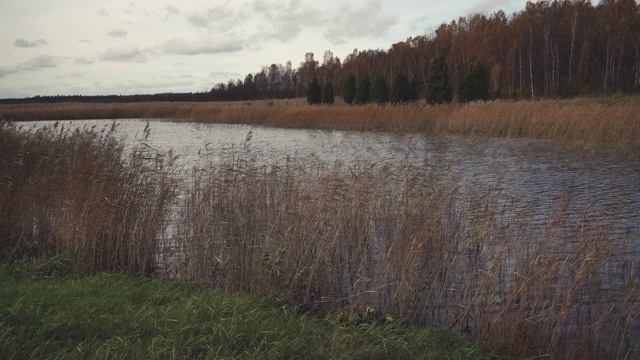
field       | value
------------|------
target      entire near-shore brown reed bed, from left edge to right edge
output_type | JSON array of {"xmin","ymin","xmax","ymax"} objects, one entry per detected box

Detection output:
[{"xmin": 0, "ymin": 120, "xmax": 640, "ymax": 359}]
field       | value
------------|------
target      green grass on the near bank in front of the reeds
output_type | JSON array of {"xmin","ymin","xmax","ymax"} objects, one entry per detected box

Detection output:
[{"xmin": 0, "ymin": 258, "xmax": 488, "ymax": 359}]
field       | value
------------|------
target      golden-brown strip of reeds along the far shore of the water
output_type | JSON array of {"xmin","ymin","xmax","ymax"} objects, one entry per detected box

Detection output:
[{"xmin": 0, "ymin": 97, "xmax": 640, "ymax": 160}]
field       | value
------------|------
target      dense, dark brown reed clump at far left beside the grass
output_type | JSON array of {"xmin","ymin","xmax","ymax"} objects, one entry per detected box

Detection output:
[{"xmin": 0, "ymin": 122, "xmax": 177, "ymax": 274}]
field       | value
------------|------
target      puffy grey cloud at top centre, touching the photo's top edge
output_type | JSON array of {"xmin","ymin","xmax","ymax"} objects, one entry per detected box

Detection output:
[{"xmin": 324, "ymin": 0, "xmax": 398, "ymax": 44}]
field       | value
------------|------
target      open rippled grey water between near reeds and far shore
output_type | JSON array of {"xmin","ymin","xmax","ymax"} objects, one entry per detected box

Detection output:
[{"xmin": 21, "ymin": 120, "xmax": 640, "ymax": 241}]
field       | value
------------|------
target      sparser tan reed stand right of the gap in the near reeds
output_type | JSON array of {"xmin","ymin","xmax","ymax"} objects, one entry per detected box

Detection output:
[{"xmin": 174, "ymin": 145, "xmax": 640, "ymax": 359}]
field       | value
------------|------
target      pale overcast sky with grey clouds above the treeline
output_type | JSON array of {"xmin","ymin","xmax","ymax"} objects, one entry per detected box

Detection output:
[{"xmin": 0, "ymin": 0, "xmax": 526, "ymax": 98}]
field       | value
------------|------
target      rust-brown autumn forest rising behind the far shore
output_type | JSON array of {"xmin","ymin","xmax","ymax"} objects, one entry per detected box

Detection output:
[{"xmin": 2, "ymin": 0, "xmax": 640, "ymax": 103}]
